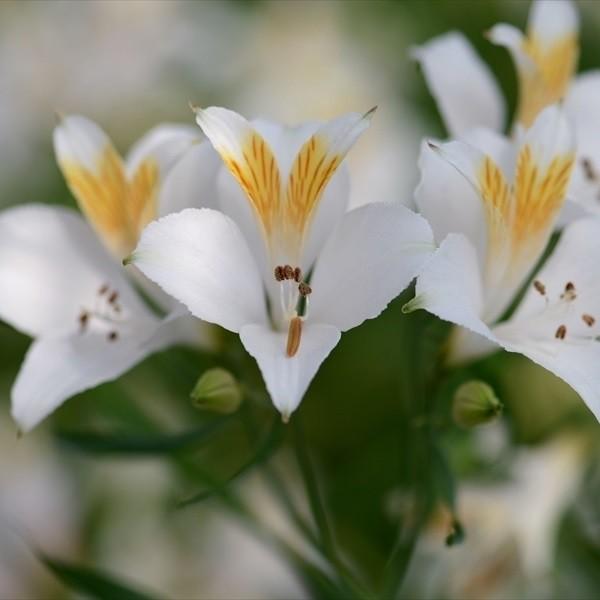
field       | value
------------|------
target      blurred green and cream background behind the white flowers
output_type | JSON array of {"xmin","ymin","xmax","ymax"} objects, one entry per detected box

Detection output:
[{"xmin": 0, "ymin": 0, "xmax": 600, "ymax": 600}]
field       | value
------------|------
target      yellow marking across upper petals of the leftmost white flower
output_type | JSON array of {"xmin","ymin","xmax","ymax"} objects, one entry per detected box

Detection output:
[{"xmin": 60, "ymin": 145, "xmax": 159, "ymax": 258}]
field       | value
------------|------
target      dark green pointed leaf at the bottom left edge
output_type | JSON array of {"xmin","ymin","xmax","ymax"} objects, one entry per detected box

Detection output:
[{"xmin": 38, "ymin": 554, "xmax": 164, "ymax": 600}]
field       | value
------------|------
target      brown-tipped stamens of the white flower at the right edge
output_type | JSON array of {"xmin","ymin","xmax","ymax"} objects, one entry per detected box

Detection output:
[{"xmin": 533, "ymin": 280, "xmax": 600, "ymax": 341}]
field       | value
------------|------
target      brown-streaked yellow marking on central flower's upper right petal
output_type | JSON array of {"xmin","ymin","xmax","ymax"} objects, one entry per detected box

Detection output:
[{"xmin": 284, "ymin": 134, "xmax": 343, "ymax": 250}]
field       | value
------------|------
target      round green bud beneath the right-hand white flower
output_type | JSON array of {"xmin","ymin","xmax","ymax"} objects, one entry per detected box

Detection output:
[{"xmin": 452, "ymin": 380, "xmax": 503, "ymax": 429}]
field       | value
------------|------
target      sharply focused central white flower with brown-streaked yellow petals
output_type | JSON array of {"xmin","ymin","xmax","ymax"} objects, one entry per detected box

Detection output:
[{"xmin": 131, "ymin": 107, "xmax": 433, "ymax": 420}]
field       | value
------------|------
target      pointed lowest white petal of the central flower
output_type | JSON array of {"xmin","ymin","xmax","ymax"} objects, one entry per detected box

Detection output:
[{"xmin": 240, "ymin": 323, "xmax": 340, "ymax": 420}]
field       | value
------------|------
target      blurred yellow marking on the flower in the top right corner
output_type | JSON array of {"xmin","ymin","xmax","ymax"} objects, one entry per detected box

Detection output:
[{"xmin": 518, "ymin": 35, "xmax": 579, "ymax": 127}]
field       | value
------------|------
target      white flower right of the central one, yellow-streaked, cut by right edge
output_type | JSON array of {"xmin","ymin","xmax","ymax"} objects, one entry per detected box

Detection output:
[{"xmin": 412, "ymin": 106, "xmax": 600, "ymax": 418}]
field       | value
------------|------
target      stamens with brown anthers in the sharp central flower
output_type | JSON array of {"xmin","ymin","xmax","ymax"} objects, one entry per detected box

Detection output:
[{"xmin": 274, "ymin": 265, "xmax": 312, "ymax": 358}]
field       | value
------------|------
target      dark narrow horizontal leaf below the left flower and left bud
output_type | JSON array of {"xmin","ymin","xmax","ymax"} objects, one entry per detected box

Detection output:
[{"xmin": 56, "ymin": 417, "xmax": 231, "ymax": 456}]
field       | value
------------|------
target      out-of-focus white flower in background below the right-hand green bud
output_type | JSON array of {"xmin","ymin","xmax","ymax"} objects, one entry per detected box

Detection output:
[{"xmin": 407, "ymin": 435, "xmax": 585, "ymax": 600}]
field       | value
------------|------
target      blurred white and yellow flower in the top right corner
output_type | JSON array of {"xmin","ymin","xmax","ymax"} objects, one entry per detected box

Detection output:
[{"xmin": 413, "ymin": 0, "xmax": 600, "ymax": 214}]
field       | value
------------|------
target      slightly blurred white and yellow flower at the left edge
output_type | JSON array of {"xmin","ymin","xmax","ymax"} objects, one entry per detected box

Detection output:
[{"xmin": 0, "ymin": 116, "xmax": 218, "ymax": 431}]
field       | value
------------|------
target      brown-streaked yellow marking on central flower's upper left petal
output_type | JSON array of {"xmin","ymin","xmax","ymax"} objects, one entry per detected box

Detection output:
[{"xmin": 221, "ymin": 132, "xmax": 281, "ymax": 239}]
